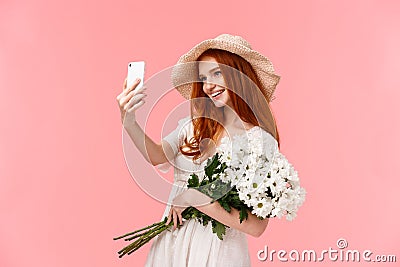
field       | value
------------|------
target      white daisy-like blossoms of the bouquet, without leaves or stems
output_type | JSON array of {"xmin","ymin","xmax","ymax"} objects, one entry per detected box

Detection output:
[{"xmin": 218, "ymin": 129, "xmax": 306, "ymax": 221}]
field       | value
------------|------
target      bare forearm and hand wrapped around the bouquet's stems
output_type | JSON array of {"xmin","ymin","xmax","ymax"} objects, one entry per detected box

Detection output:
[{"xmin": 171, "ymin": 188, "xmax": 268, "ymax": 237}]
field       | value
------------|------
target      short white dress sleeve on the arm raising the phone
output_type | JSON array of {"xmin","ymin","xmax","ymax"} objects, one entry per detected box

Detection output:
[{"xmin": 156, "ymin": 116, "xmax": 190, "ymax": 173}]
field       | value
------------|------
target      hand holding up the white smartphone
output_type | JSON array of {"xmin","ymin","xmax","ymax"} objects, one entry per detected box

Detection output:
[{"xmin": 117, "ymin": 79, "xmax": 146, "ymax": 126}]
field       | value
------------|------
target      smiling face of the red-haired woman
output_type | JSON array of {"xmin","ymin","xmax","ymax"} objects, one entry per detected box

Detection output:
[{"xmin": 199, "ymin": 56, "xmax": 232, "ymax": 107}]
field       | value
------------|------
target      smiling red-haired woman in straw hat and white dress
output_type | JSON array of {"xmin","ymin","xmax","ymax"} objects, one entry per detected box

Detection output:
[{"xmin": 117, "ymin": 34, "xmax": 280, "ymax": 266}]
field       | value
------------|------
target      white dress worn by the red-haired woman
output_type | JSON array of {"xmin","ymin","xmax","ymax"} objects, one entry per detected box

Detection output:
[{"xmin": 145, "ymin": 116, "xmax": 251, "ymax": 267}]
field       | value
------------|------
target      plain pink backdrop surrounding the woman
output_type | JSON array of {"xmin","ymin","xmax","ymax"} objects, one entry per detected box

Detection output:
[{"xmin": 0, "ymin": 0, "xmax": 400, "ymax": 267}]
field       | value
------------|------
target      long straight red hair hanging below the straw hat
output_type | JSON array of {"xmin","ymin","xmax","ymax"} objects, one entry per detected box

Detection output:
[{"xmin": 180, "ymin": 49, "xmax": 280, "ymax": 160}]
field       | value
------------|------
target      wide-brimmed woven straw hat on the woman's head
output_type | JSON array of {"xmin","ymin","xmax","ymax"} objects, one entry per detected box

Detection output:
[{"xmin": 171, "ymin": 34, "xmax": 280, "ymax": 102}]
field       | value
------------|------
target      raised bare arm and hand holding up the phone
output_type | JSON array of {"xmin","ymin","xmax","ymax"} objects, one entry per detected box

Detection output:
[{"xmin": 117, "ymin": 79, "xmax": 174, "ymax": 165}]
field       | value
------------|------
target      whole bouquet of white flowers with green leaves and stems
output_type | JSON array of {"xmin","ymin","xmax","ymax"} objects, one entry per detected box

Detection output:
[{"xmin": 114, "ymin": 128, "xmax": 306, "ymax": 257}]
